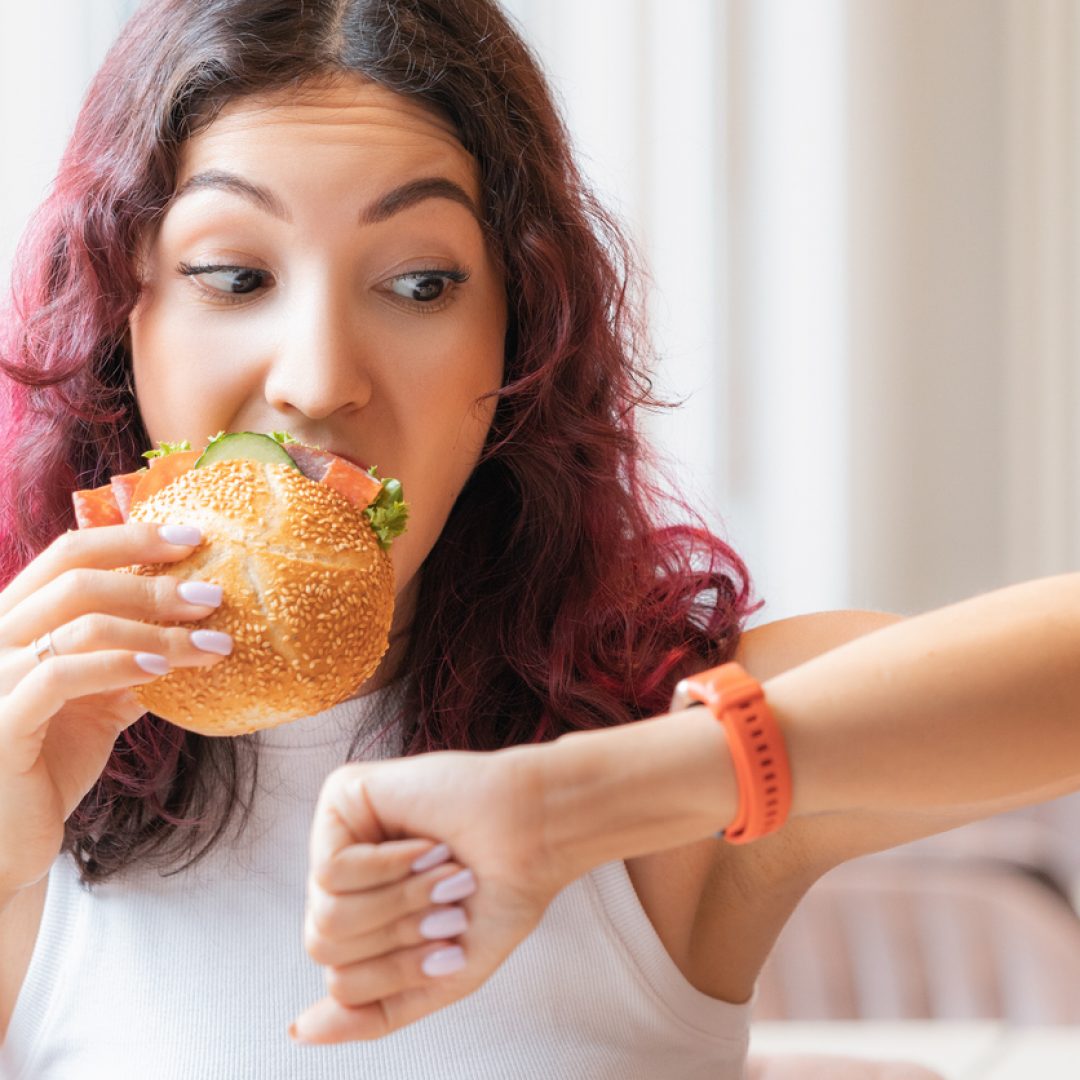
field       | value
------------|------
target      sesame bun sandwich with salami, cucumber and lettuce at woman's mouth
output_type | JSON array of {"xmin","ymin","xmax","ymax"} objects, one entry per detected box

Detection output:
[{"xmin": 72, "ymin": 432, "xmax": 408, "ymax": 735}]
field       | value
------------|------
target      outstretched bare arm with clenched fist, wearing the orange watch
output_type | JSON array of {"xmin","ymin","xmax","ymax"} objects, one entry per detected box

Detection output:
[{"xmin": 297, "ymin": 575, "xmax": 1080, "ymax": 1042}]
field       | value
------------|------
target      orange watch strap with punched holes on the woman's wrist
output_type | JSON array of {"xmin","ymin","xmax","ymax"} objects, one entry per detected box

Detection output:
[{"xmin": 672, "ymin": 663, "xmax": 792, "ymax": 843}]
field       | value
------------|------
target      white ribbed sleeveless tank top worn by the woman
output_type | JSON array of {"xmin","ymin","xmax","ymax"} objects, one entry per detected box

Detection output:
[{"xmin": 0, "ymin": 684, "xmax": 754, "ymax": 1080}]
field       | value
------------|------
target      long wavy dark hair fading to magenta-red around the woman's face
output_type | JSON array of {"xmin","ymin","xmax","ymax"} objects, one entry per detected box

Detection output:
[{"xmin": 0, "ymin": 0, "xmax": 764, "ymax": 885}]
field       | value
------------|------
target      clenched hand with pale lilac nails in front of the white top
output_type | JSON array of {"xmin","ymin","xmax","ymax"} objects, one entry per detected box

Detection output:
[{"xmin": 289, "ymin": 747, "xmax": 572, "ymax": 1043}]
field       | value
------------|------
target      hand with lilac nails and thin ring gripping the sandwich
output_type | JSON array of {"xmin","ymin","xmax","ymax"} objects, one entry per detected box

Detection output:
[{"xmin": 0, "ymin": 523, "xmax": 224, "ymax": 907}]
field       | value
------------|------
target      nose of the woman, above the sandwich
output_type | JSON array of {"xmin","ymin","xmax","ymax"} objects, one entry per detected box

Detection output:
[{"xmin": 265, "ymin": 284, "xmax": 373, "ymax": 420}]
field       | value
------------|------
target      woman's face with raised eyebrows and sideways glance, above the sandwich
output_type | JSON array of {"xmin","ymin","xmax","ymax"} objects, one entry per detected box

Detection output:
[{"xmin": 131, "ymin": 79, "xmax": 507, "ymax": 682}]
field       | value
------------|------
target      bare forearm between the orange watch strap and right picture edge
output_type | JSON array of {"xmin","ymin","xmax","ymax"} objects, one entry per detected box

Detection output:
[{"xmin": 766, "ymin": 573, "xmax": 1080, "ymax": 813}]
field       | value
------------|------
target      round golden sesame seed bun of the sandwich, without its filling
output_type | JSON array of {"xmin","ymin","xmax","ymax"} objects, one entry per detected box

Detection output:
[{"xmin": 124, "ymin": 459, "xmax": 394, "ymax": 735}]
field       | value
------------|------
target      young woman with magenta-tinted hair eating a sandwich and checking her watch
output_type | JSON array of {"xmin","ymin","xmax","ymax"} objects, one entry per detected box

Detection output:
[{"xmin": 0, "ymin": 0, "xmax": 1080, "ymax": 1080}]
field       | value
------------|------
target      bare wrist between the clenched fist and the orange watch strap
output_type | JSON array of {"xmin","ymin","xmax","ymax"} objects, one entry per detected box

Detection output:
[{"xmin": 540, "ymin": 708, "xmax": 738, "ymax": 881}]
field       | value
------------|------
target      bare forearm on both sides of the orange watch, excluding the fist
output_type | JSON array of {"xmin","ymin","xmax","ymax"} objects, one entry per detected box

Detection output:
[{"xmin": 544, "ymin": 573, "xmax": 1080, "ymax": 872}]
